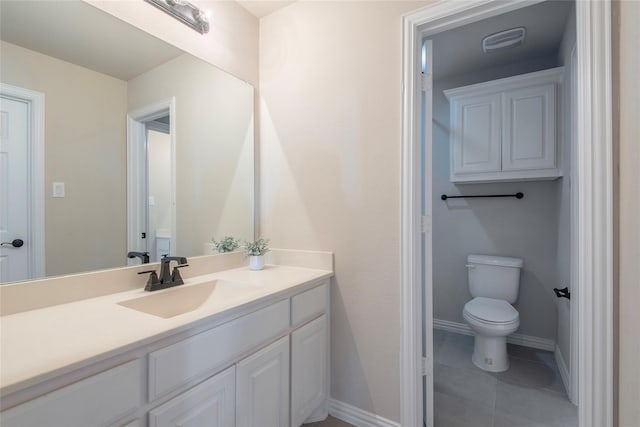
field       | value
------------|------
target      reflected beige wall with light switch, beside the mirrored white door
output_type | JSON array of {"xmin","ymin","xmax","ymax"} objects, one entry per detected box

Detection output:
[{"xmin": 0, "ymin": 42, "xmax": 127, "ymax": 276}]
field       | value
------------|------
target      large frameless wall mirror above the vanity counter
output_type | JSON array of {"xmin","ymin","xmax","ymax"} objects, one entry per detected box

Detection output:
[{"xmin": 0, "ymin": 0, "xmax": 254, "ymax": 283}]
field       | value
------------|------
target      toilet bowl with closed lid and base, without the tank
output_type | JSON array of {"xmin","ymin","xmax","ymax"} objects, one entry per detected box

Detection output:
[{"xmin": 462, "ymin": 297, "xmax": 520, "ymax": 372}]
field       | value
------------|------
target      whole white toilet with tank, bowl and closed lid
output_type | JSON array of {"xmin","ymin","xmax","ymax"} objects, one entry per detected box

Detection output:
[{"xmin": 462, "ymin": 255, "xmax": 523, "ymax": 372}]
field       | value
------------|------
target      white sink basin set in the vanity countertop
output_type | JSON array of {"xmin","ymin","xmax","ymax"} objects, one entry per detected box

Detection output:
[{"xmin": 118, "ymin": 280, "xmax": 256, "ymax": 319}]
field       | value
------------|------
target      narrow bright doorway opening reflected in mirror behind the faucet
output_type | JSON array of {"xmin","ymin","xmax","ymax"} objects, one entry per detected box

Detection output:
[{"xmin": 146, "ymin": 116, "xmax": 171, "ymax": 262}]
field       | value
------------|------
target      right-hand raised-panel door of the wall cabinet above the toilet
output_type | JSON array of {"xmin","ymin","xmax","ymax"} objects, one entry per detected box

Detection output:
[{"xmin": 502, "ymin": 84, "xmax": 556, "ymax": 171}]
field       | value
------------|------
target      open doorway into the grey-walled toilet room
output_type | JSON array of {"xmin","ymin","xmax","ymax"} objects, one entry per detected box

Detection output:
[{"xmin": 422, "ymin": 1, "xmax": 577, "ymax": 427}]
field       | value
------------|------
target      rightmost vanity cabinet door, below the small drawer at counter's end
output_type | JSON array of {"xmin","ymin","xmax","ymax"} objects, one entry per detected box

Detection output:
[{"xmin": 291, "ymin": 315, "xmax": 328, "ymax": 427}]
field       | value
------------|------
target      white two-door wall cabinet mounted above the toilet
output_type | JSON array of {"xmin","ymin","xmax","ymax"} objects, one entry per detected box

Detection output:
[{"xmin": 444, "ymin": 67, "xmax": 563, "ymax": 183}]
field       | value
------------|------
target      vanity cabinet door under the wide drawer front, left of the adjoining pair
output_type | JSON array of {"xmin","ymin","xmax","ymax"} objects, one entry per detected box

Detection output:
[{"xmin": 149, "ymin": 367, "xmax": 236, "ymax": 427}]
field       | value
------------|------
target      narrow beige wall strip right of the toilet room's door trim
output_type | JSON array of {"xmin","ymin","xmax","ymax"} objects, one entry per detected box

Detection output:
[{"xmin": 614, "ymin": 1, "xmax": 640, "ymax": 427}]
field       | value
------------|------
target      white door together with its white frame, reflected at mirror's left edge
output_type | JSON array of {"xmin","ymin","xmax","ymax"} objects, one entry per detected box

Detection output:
[{"xmin": 0, "ymin": 84, "xmax": 44, "ymax": 283}]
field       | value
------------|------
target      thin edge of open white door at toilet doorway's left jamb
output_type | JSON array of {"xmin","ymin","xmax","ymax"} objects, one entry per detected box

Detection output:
[{"xmin": 421, "ymin": 40, "xmax": 433, "ymax": 427}]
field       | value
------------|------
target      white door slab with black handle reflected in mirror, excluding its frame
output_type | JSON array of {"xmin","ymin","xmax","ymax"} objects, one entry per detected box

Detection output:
[{"xmin": 0, "ymin": 94, "xmax": 31, "ymax": 283}]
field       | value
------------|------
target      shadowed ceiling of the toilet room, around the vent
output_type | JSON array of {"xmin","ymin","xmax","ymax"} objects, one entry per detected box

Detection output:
[{"xmin": 429, "ymin": 0, "xmax": 573, "ymax": 78}]
